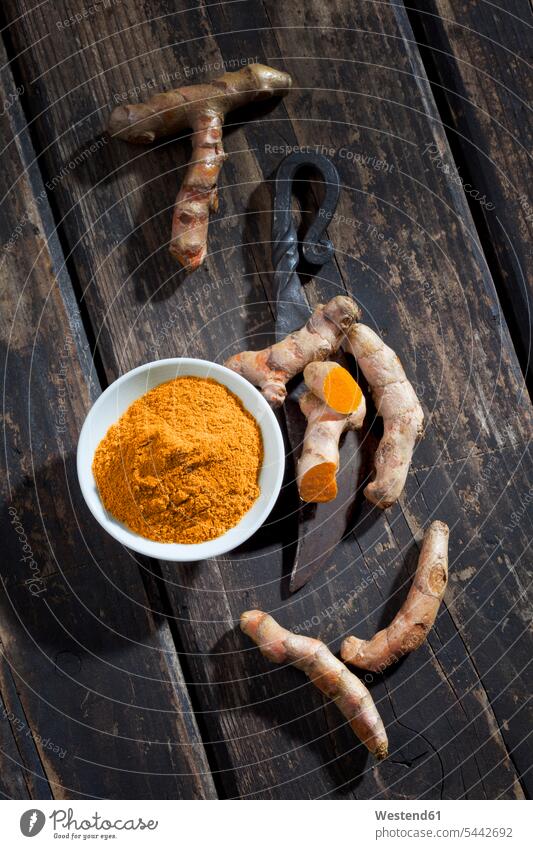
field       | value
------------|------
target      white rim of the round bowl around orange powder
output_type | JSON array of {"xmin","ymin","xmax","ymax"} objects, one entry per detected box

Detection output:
[{"xmin": 76, "ymin": 357, "xmax": 285, "ymax": 563}]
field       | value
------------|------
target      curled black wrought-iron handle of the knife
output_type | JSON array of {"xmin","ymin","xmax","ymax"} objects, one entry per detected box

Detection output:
[{"xmin": 272, "ymin": 153, "xmax": 340, "ymax": 340}]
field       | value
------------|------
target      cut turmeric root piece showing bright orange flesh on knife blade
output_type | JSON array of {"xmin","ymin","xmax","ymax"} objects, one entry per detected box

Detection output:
[{"xmin": 296, "ymin": 386, "xmax": 366, "ymax": 503}]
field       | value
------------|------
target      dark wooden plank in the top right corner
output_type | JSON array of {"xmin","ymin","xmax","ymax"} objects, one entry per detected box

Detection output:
[{"xmin": 409, "ymin": 0, "xmax": 533, "ymax": 378}]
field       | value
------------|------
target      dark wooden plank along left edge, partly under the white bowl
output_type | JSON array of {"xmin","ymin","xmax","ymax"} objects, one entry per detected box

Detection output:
[{"xmin": 0, "ymin": 36, "xmax": 214, "ymax": 798}]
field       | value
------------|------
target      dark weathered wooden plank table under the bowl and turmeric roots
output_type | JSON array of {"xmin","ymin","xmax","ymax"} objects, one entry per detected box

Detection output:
[{"xmin": 0, "ymin": 0, "xmax": 533, "ymax": 799}]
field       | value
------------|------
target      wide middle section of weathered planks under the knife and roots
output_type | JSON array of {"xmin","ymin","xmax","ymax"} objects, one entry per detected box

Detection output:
[{"xmin": 1, "ymin": 0, "xmax": 531, "ymax": 798}]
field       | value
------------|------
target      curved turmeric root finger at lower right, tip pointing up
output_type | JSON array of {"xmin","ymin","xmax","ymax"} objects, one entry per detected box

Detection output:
[{"xmin": 341, "ymin": 522, "xmax": 449, "ymax": 672}]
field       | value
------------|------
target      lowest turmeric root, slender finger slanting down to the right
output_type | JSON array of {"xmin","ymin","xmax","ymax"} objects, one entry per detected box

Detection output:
[{"xmin": 241, "ymin": 610, "xmax": 388, "ymax": 760}]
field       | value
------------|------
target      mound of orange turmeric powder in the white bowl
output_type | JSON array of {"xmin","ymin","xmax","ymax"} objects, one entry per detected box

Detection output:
[{"xmin": 93, "ymin": 377, "xmax": 263, "ymax": 543}]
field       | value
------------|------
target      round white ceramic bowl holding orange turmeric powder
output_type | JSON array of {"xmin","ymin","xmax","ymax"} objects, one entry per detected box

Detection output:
[{"xmin": 77, "ymin": 358, "xmax": 285, "ymax": 561}]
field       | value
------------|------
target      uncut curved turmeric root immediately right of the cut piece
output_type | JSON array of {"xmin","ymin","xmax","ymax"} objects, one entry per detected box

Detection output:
[{"xmin": 346, "ymin": 324, "xmax": 424, "ymax": 509}]
